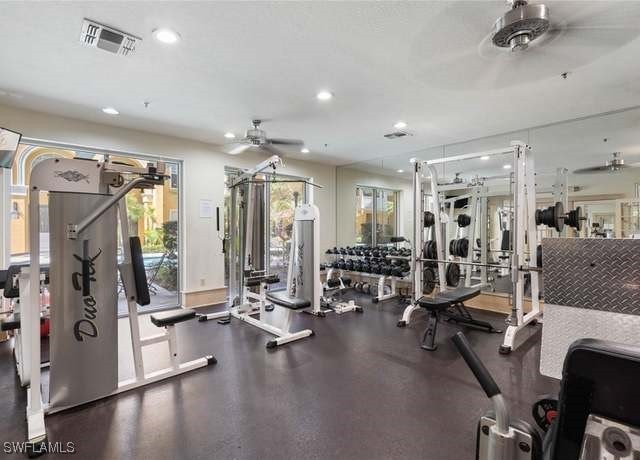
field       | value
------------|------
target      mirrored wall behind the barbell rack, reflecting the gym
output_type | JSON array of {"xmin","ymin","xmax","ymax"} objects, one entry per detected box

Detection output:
[{"xmin": 337, "ymin": 107, "xmax": 640, "ymax": 293}]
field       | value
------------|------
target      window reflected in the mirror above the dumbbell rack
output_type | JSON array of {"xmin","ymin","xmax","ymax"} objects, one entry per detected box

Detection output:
[{"xmin": 356, "ymin": 186, "xmax": 399, "ymax": 246}]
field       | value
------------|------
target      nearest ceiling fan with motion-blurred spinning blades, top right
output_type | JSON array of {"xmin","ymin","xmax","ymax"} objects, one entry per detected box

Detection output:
[{"xmin": 413, "ymin": 0, "xmax": 640, "ymax": 89}]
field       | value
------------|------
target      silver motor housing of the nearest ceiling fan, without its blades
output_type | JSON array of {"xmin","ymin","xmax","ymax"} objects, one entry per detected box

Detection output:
[{"xmin": 493, "ymin": 2, "xmax": 550, "ymax": 51}]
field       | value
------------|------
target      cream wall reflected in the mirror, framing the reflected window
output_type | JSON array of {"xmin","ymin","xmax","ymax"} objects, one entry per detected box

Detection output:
[{"xmin": 336, "ymin": 167, "xmax": 413, "ymax": 246}]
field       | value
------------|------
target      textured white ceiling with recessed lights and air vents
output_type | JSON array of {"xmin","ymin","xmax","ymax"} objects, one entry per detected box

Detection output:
[{"xmin": 0, "ymin": 0, "xmax": 640, "ymax": 163}]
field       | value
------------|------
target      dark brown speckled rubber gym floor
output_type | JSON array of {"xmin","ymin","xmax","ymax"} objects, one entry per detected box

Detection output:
[{"xmin": 0, "ymin": 297, "xmax": 558, "ymax": 460}]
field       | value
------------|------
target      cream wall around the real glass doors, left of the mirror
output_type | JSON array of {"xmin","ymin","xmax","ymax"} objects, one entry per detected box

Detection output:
[{"xmin": 0, "ymin": 105, "xmax": 336, "ymax": 300}]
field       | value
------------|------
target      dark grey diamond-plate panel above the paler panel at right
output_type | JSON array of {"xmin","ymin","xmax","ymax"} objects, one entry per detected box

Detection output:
[{"xmin": 542, "ymin": 238, "xmax": 640, "ymax": 315}]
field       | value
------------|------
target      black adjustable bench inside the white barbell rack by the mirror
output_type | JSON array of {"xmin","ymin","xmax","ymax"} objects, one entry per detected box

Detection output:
[{"xmin": 418, "ymin": 287, "xmax": 502, "ymax": 351}]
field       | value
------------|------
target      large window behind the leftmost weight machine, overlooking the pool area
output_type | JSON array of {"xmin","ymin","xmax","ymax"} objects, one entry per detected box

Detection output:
[{"xmin": 10, "ymin": 144, "xmax": 180, "ymax": 315}]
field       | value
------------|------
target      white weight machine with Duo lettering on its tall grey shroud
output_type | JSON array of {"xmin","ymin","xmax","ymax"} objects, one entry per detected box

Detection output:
[{"xmin": 19, "ymin": 158, "xmax": 216, "ymax": 453}]
